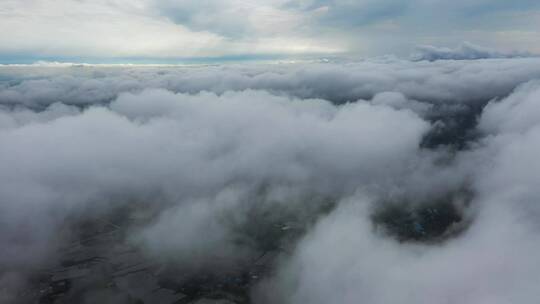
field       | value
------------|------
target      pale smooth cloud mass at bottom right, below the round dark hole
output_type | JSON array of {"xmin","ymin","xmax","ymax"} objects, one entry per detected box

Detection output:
[{"xmin": 255, "ymin": 192, "xmax": 540, "ymax": 303}]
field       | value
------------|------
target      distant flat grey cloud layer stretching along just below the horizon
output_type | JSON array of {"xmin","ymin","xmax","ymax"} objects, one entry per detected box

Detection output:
[{"xmin": 0, "ymin": 57, "xmax": 540, "ymax": 108}]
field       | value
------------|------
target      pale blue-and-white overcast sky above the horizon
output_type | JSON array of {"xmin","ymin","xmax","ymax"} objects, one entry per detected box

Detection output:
[{"xmin": 0, "ymin": 0, "xmax": 540, "ymax": 63}]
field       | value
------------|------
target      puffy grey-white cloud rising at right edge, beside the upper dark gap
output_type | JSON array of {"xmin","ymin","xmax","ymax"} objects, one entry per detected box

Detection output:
[{"xmin": 479, "ymin": 81, "xmax": 540, "ymax": 221}]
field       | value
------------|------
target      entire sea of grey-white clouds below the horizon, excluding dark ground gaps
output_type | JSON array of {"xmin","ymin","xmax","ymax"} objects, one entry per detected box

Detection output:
[{"xmin": 0, "ymin": 58, "xmax": 540, "ymax": 304}]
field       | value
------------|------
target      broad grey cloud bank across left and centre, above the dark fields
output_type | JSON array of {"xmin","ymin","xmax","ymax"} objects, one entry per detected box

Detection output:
[{"xmin": 0, "ymin": 86, "xmax": 428, "ymax": 298}]
